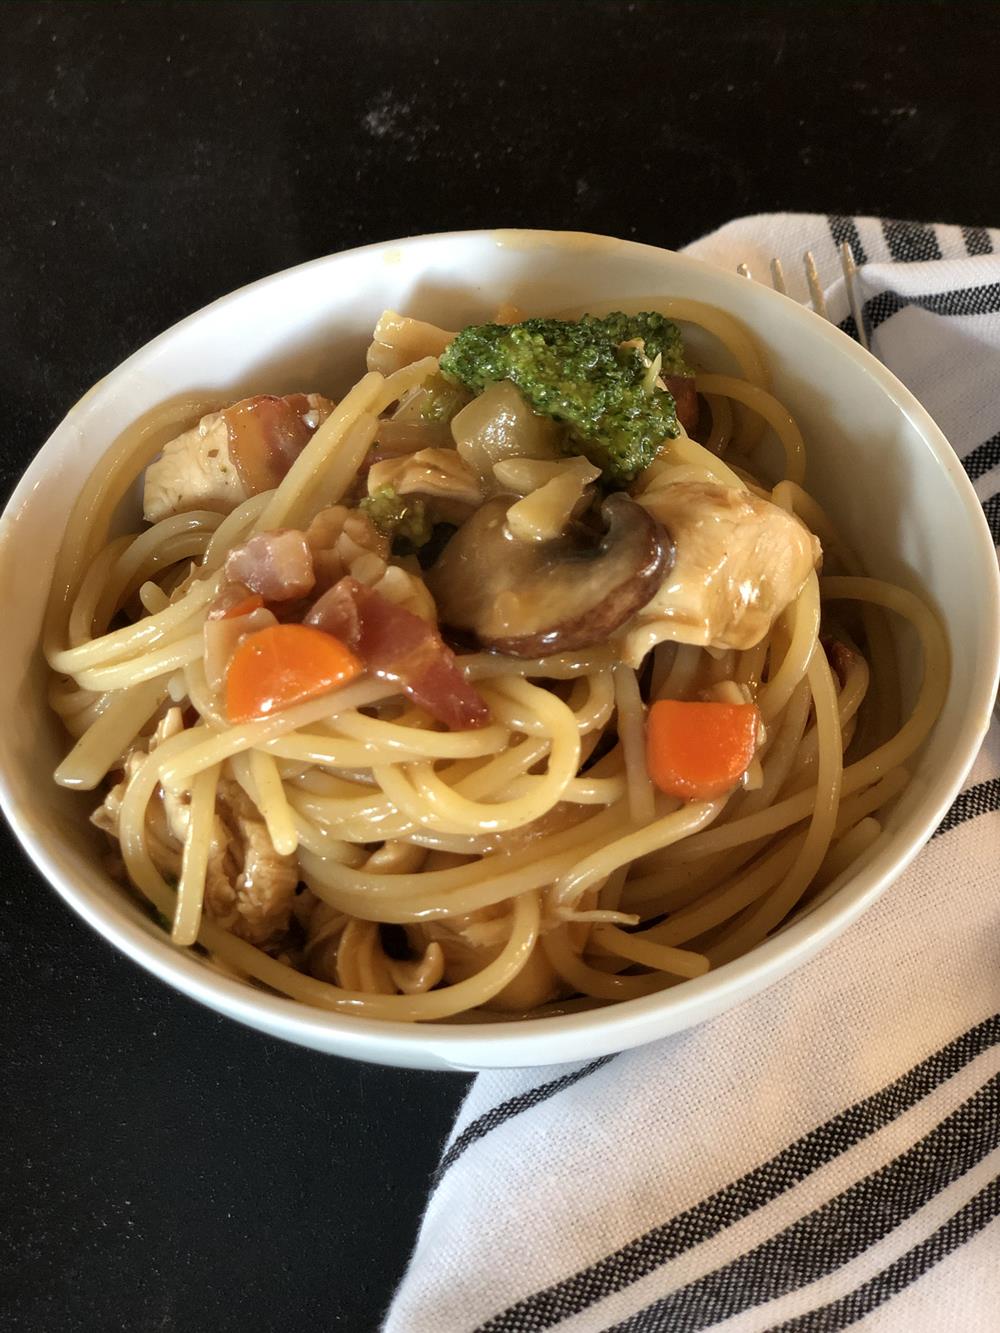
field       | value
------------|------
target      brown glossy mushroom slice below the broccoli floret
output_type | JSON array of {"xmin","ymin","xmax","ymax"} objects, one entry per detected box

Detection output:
[{"xmin": 427, "ymin": 493, "xmax": 673, "ymax": 657}]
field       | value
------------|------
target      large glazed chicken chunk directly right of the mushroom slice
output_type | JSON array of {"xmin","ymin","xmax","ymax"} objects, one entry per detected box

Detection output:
[{"xmin": 636, "ymin": 481, "xmax": 821, "ymax": 649}]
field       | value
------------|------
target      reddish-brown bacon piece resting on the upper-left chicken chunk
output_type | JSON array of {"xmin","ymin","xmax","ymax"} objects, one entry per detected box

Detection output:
[{"xmin": 221, "ymin": 393, "xmax": 333, "ymax": 496}]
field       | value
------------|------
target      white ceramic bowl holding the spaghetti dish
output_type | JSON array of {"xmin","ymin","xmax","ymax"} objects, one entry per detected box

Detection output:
[{"xmin": 0, "ymin": 232, "xmax": 1000, "ymax": 1069}]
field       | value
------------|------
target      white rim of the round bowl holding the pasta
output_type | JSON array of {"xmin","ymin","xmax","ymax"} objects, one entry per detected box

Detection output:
[{"xmin": 0, "ymin": 228, "xmax": 1000, "ymax": 1068}]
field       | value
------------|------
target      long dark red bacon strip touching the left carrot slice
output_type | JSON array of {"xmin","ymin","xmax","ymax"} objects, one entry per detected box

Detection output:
[{"xmin": 305, "ymin": 577, "xmax": 489, "ymax": 730}]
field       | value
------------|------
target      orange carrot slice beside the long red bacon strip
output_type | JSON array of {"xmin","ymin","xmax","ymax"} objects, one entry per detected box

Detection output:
[{"xmin": 225, "ymin": 625, "xmax": 364, "ymax": 722}]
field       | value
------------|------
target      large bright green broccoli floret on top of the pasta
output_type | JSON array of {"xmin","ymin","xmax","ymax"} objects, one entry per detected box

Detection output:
[{"xmin": 440, "ymin": 313, "xmax": 691, "ymax": 485}]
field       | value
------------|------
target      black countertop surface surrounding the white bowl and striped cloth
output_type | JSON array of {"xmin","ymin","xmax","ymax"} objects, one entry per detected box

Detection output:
[{"xmin": 0, "ymin": 0, "xmax": 1000, "ymax": 1333}]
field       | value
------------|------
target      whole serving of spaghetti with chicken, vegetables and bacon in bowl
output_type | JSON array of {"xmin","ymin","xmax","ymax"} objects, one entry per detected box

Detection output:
[{"xmin": 44, "ymin": 301, "xmax": 948, "ymax": 1022}]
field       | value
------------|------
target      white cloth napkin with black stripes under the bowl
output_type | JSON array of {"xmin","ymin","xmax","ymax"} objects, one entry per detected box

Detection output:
[{"xmin": 385, "ymin": 215, "xmax": 1000, "ymax": 1333}]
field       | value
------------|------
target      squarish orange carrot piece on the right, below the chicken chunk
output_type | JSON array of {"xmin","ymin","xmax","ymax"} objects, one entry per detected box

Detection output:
[{"xmin": 645, "ymin": 698, "xmax": 760, "ymax": 801}]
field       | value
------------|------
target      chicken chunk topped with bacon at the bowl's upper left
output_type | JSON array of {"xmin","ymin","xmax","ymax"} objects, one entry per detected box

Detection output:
[{"xmin": 143, "ymin": 393, "xmax": 332, "ymax": 523}]
